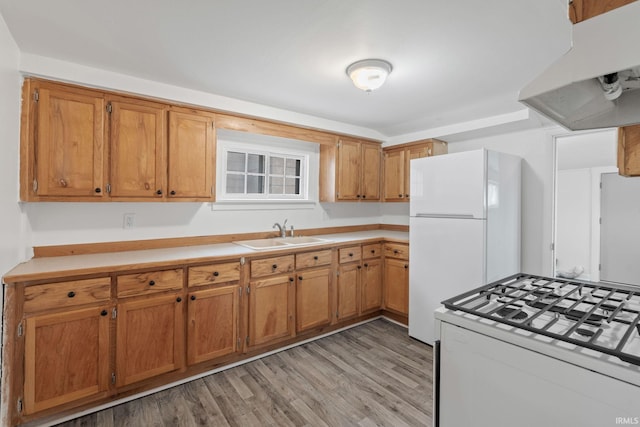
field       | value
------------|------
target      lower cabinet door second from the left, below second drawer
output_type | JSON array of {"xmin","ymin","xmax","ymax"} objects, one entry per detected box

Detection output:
[{"xmin": 116, "ymin": 294, "xmax": 184, "ymax": 387}]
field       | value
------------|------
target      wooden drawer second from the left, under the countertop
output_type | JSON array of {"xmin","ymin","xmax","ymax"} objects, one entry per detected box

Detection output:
[{"xmin": 116, "ymin": 268, "xmax": 183, "ymax": 298}]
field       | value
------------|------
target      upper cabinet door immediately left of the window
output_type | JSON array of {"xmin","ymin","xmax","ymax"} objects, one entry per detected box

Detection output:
[{"xmin": 168, "ymin": 110, "xmax": 215, "ymax": 201}]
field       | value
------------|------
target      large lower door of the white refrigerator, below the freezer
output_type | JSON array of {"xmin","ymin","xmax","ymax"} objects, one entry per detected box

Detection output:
[{"xmin": 409, "ymin": 217, "xmax": 486, "ymax": 345}]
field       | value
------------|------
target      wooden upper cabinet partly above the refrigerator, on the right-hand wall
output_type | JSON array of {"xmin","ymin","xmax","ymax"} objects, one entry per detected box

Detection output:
[{"xmin": 382, "ymin": 139, "xmax": 447, "ymax": 202}]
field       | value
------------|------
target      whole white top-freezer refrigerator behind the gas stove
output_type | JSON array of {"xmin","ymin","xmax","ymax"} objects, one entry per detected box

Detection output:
[{"xmin": 409, "ymin": 149, "xmax": 521, "ymax": 345}]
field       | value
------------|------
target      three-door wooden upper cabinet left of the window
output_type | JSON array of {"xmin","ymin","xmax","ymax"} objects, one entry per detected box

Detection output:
[{"xmin": 20, "ymin": 79, "xmax": 215, "ymax": 202}]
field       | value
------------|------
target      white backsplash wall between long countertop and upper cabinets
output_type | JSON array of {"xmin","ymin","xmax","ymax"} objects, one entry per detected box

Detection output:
[{"xmin": 24, "ymin": 202, "xmax": 381, "ymax": 246}]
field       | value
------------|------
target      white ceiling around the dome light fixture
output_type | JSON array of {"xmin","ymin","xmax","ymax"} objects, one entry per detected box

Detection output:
[{"xmin": 0, "ymin": 0, "xmax": 571, "ymax": 137}]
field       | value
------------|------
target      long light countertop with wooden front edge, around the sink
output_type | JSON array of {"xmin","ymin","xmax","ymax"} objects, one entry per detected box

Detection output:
[{"xmin": 3, "ymin": 230, "xmax": 409, "ymax": 283}]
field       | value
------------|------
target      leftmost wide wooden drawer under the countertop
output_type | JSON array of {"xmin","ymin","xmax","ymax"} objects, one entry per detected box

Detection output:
[{"xmin": 24, "ymin": 277, "xmax": 111, "ymax": 312}]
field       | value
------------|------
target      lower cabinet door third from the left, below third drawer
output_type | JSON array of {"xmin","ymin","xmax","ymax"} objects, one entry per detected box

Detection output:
[{"xmin": 187, "ymin": 285, "xmax": 240, "ymax": 365}]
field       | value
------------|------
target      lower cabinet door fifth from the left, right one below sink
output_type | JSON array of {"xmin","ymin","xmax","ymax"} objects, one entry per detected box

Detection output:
[{"xmin": 296, "ymin": 268, "xmax": 331, "ymax": 332}]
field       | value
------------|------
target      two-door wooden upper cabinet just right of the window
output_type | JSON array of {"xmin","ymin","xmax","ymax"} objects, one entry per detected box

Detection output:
[{"xmin": 320, "ymin": 137, "xmax": 382, "ymax": 202}]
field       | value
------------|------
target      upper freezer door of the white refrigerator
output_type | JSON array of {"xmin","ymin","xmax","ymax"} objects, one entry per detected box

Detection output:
[{"xmin": 409, "ymin": 150, "xmax": 487, "ymax": 218}]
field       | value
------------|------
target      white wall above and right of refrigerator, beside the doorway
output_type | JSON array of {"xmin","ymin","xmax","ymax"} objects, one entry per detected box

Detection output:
[{"xmin": 449, "ymin": 128, "xmax": 561, "ymax": 276}]
